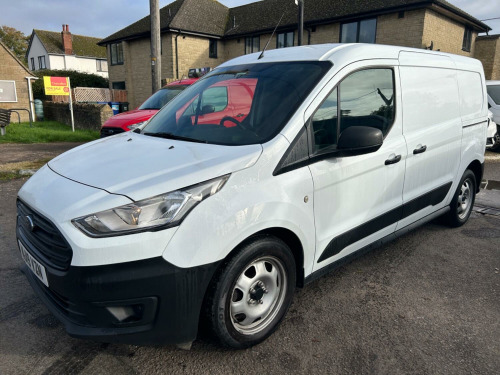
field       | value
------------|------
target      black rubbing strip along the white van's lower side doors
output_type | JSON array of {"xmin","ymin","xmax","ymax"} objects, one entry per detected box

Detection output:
[{"xmin": 318, "ymin": 182, "xmax": 452, "ymax": 263}]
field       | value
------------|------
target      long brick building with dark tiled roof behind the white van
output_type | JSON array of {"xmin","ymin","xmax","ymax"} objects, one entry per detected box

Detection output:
[{"xmin": 99, "ymin": 0, "xmax": 492, "ymax": 107}]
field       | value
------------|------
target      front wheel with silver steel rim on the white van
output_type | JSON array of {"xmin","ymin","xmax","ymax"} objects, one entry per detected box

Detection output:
[{"xmin": 205, "ymin": 236, "xmax": 296, "ymax": 348}]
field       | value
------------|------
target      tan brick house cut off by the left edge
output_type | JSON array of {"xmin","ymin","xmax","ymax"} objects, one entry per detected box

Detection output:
[{"xmin": 0, "ymin": 42, "xmax": 35, "ymax": 122}]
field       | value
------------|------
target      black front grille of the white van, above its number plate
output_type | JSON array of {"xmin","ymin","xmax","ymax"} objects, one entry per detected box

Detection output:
[{"xmin": 17, "ymin": 200, "xmax": 73, "ymax": 270}]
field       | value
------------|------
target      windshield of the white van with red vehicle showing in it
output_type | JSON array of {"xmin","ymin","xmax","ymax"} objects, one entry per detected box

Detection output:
[{"xmin": 142, "ymin": 61, "xmax": 332, "ymax": 145}]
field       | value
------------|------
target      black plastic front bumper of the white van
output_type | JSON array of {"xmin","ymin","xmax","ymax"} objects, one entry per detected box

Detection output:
[{"xmin": 23, "ymin": 236, "xmax": 218, "ymax": 344}]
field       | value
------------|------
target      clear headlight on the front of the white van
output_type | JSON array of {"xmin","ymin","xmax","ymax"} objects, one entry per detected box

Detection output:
[{"xmin": 72, "ymin": 175, "xmax": 229, "ymax": 237}]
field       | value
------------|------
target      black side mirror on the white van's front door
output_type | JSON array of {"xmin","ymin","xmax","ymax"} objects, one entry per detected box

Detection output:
[{"xmin": 337, "ymin": 126, "xmax": 384, "ymax": 156}]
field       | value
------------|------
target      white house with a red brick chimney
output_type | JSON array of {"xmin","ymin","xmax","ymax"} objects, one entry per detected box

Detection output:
[{"xmin": 26, "ymin": 25, "xmax": 108, "ymax": 78}]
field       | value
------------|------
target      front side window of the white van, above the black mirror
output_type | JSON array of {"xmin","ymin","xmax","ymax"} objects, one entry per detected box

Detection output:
[{"xmin": 311, "ymin": 68, "xmax": 395, "ymax": 153}]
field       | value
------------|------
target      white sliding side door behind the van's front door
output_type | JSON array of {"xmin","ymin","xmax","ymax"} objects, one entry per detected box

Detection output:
[{"xmin": 397, "ymin": 52, "xmax": 462, "ymax": 229}]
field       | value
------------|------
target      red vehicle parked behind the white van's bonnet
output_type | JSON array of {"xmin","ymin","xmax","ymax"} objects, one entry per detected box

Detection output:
[{"xmin": 101, "ymin": 78, "xmax": 198, "ymax": 138}]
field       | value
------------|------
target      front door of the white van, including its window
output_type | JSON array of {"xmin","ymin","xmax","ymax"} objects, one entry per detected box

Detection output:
[{"xmin": 306, "ymin": 60, "xmax": 406, "ymax": 271}]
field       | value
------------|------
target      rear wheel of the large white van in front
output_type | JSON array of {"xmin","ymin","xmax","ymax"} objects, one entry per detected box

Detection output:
[{"xmin": 448, "ymin": 169, "xmax": 477, "ymax": 227}]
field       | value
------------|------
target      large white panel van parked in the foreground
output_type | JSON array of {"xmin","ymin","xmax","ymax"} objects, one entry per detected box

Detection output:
[{"xmin": 17, "ymin": 44, "xmax": 488, "ymax": 348}]
